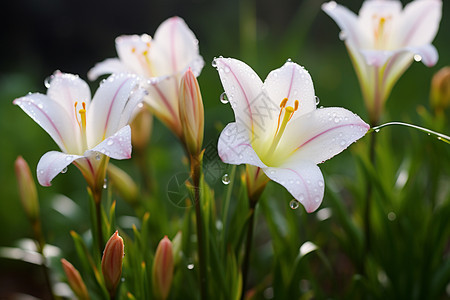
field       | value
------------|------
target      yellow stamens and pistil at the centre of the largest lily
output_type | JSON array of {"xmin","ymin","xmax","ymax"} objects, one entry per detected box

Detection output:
[{"xmin": 261, "ymin": 98, "xmax": 299, "ymax": 166}]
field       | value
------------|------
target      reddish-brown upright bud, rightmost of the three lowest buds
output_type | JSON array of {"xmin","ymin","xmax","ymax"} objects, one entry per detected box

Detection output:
[{"xmin": 152, "ymin": 236, "xmax": 173, "ymax": 300}]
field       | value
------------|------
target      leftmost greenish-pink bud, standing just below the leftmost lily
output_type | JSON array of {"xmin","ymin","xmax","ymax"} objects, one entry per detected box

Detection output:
[{"xmin": 14, "ymin": 156, "xmax": 39, "ymax": 221}]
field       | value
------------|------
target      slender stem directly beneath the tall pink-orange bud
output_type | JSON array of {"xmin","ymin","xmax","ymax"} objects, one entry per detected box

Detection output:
[{"xmin": 191, "ymin": 156, "xmax": 208, "ymax": 300}]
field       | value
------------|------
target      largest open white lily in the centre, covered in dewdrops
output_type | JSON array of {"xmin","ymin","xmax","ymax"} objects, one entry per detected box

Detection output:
[{"xmin": 213, "ymin": 58, "xmax": 369, "ymax": 212}]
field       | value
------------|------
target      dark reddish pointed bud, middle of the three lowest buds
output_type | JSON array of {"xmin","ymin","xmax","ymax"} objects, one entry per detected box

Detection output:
[{"xmin": 102, "ymin": 231, "xmax": 124, "ymax": 297}]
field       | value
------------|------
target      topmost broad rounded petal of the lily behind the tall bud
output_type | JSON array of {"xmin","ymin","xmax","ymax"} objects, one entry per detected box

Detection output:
[{"xmin": 149, "ymin": 17, "xmax": 203, "ymax": 76}]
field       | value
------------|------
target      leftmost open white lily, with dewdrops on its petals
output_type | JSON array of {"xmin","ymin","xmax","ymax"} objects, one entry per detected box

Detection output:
[{"xmin": 13, "ymin": 71, "xmax": 144, "ymax": 188}]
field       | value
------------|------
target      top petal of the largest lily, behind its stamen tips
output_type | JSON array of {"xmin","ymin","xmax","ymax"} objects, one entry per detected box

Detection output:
[{"xmin": 263, "ymin": 61, "xmax": 316, "ymax": 119}]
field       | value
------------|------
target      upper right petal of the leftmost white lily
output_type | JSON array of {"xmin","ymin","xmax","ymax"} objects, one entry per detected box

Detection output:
[{"xmin": 86, "ymin": 73, "xmax": 138, "ymax": 148}]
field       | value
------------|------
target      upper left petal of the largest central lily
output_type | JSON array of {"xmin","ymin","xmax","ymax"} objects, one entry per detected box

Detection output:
[{"xmin": 214, "ymin": 57, "xmax": 266, "ymax": 135}]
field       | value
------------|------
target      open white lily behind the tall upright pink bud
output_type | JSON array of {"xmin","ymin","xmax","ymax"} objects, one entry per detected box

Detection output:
[{"xmin": 88, "ymin": 17, "xmax": 204, "ymax": 137}]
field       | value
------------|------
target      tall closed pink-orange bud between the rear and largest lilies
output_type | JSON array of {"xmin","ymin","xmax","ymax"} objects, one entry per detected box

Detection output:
[{"xmin": 179, "ymin": 69, "xmax": 204, "ymax": 156}]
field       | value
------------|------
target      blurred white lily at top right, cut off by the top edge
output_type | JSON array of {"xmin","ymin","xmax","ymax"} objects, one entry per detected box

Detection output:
[{"xmin": 322, "ymin": 0, "xmax": 442, "ymax": 125}]
